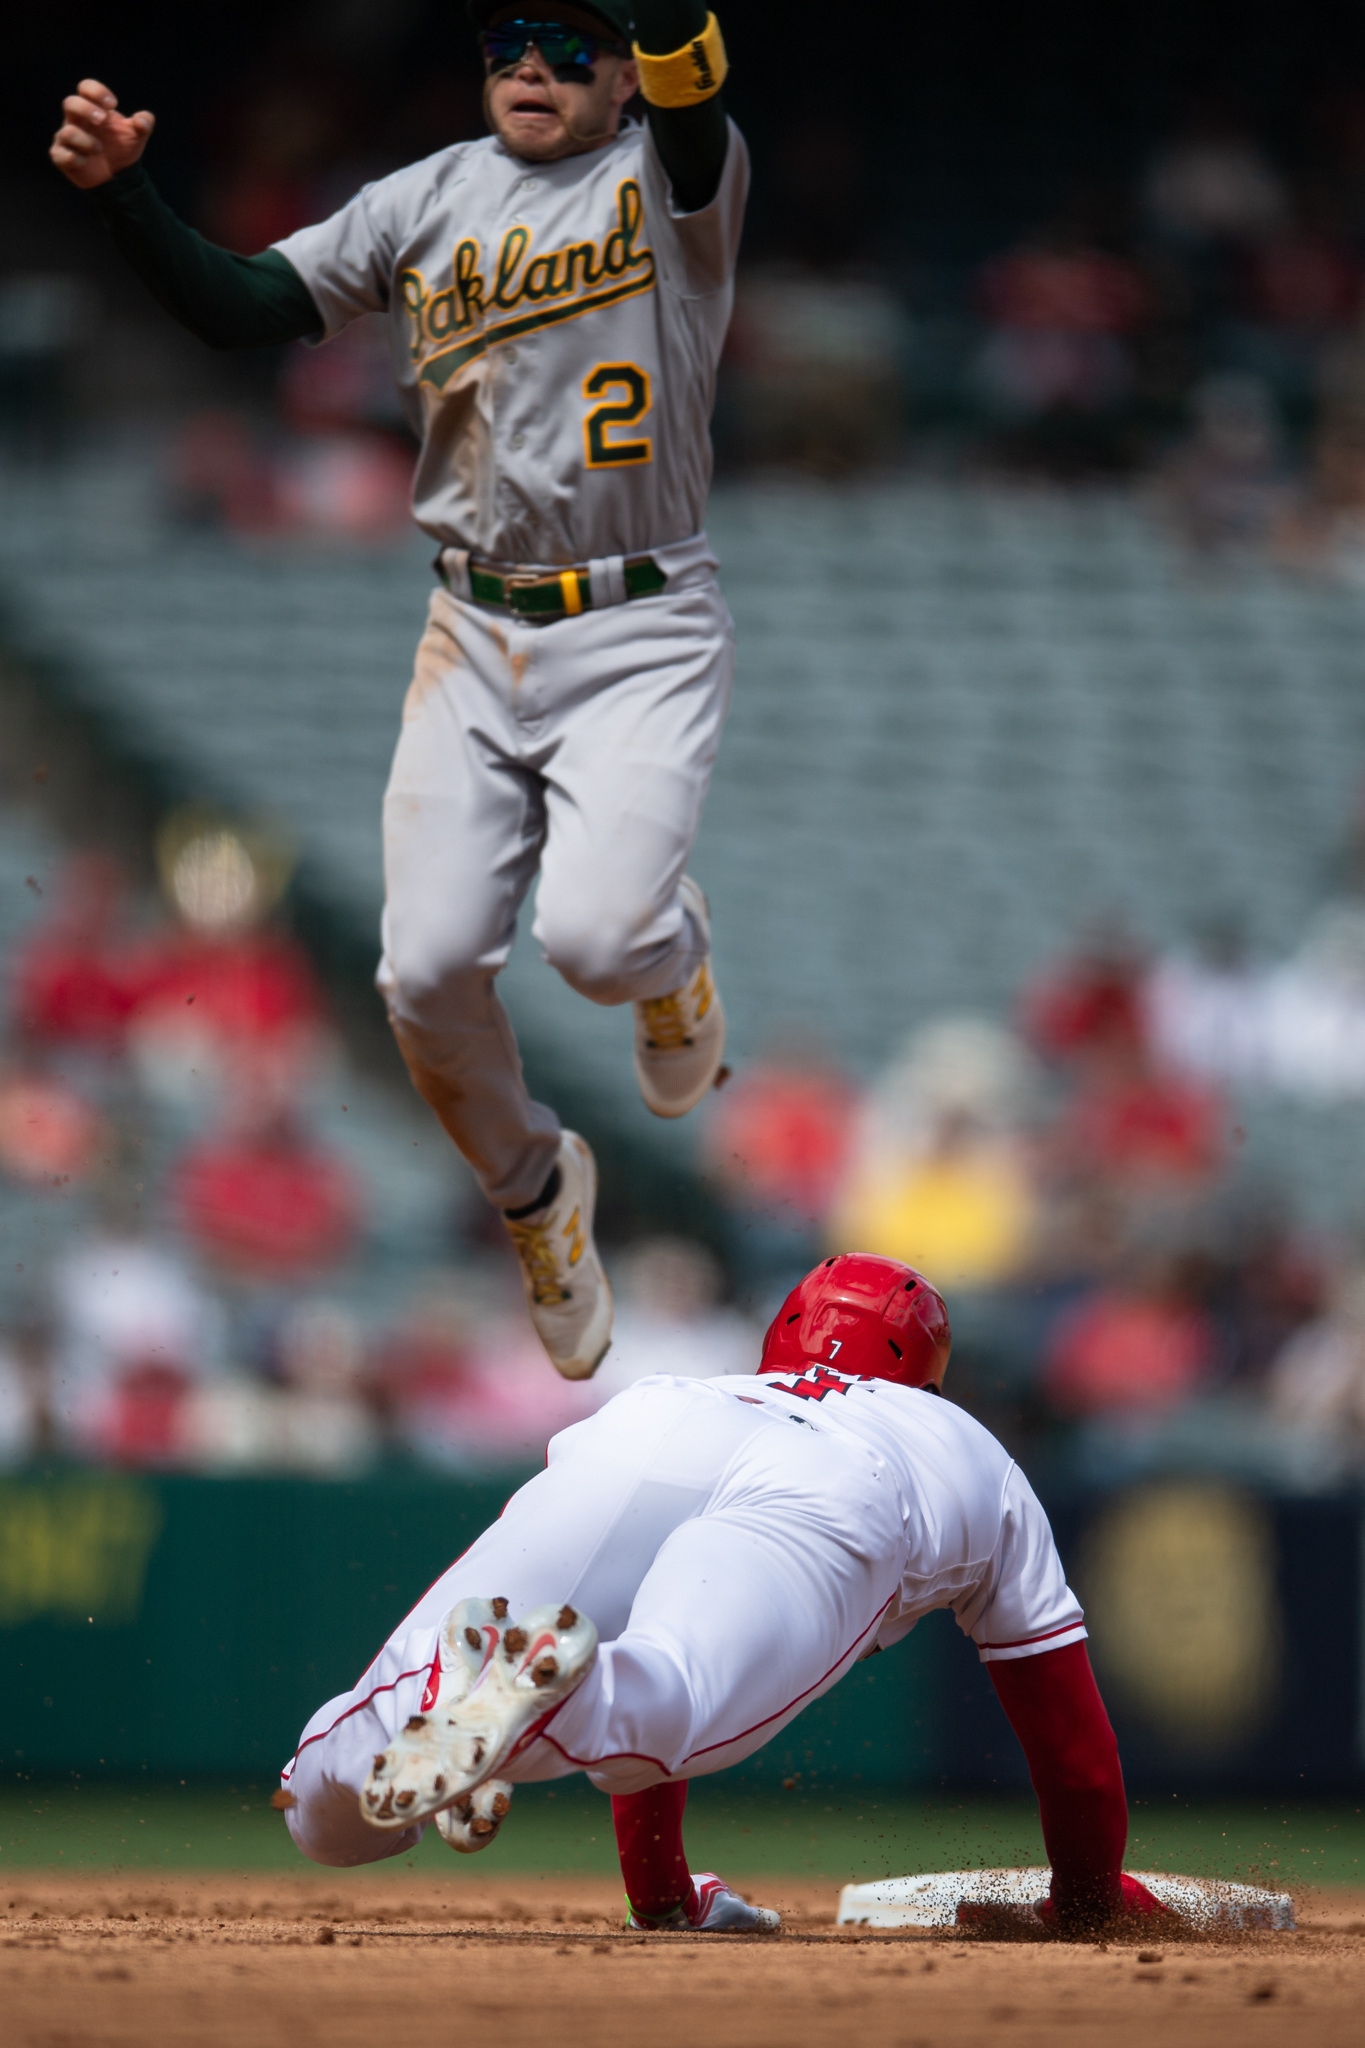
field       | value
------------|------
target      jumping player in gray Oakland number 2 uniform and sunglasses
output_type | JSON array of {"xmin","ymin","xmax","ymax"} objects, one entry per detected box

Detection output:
[{"xmin": 51, "ymin": 0, "xmax": 749, "ymax": 1378}]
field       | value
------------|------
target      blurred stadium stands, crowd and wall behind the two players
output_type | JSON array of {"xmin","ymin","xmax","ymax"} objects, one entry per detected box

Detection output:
[{"xmin": 0, "ymin": 0, "xmax": 1365, "ymax": 1876}]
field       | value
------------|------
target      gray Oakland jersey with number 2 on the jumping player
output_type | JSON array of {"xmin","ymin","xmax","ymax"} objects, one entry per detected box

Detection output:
[{"xmin": 276, "ymin": 121, "xmax": 749, "ymax": 567}]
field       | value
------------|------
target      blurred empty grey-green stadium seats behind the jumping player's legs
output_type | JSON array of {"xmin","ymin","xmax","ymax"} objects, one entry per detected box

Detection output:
[{"xmin": 0, "ymin": 455, "xmax": 1365, "ymax": 1245}]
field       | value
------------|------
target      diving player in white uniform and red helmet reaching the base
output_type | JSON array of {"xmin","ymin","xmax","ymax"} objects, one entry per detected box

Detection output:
[{"xmin": 276, "ymin": 1253, "xmax": 1162, "ymax": 1933}]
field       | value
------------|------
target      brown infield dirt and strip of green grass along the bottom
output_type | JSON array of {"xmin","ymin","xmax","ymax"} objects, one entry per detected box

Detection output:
[{"xmin": 0, "ymin": 1782, "xmax": 1365, "ymax": 2048}]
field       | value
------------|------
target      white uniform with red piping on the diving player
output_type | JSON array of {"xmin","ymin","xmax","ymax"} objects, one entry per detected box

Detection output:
[{"xmin": 282, "ymin": 1366, "xmax": 1085, "ymax": 1864}]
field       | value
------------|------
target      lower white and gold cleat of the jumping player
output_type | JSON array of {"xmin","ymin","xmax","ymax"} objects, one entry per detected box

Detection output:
[{"xmin": 503, "ymin": 1130, "xmax": 612, "ymax": 1380}]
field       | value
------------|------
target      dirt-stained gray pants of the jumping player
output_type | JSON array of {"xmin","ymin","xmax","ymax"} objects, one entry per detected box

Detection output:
[{"xmin": 377, "ymin": 535, "xmax": 735, "ymax": 1208}]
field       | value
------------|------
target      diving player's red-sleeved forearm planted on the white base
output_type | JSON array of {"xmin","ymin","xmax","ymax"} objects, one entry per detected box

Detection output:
[{"xmin": 990, "ymin": 1642, "xmax": 1128, "ymax": 1931}]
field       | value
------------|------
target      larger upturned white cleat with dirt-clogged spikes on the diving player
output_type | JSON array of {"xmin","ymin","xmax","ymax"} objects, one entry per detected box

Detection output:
[{"xmin": 360, "ymin": 1604, "xmax": 598, "ymax": 1839}]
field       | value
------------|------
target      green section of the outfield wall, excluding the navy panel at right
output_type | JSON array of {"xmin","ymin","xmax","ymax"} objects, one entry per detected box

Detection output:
[{"xmin": 0, "ymin": 1470, "xmax": 941, "ymax": 1782}]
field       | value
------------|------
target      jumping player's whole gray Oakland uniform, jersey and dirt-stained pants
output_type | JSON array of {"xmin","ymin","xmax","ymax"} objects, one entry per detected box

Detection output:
[{"xmin": 276, "ymin": 121, "xmax": 749, "ymax": 1208}]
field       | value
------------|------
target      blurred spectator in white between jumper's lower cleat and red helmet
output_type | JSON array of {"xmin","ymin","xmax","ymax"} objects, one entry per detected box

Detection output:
[{"xmin": 593, "ymin": 1237, "xmax": 761, "ymax": 1401}]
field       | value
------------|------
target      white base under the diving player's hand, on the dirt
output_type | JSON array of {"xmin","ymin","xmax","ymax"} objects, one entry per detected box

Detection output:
[{"xmin": 839, "ymin": 1868, "xmax": 1295, "ymax": 1933}]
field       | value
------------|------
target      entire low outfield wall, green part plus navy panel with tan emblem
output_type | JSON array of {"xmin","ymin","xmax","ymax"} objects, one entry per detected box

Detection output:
[{"xmin": 0, "ymin": 1468, "xmax": 1365, "ymax": 1796}]
